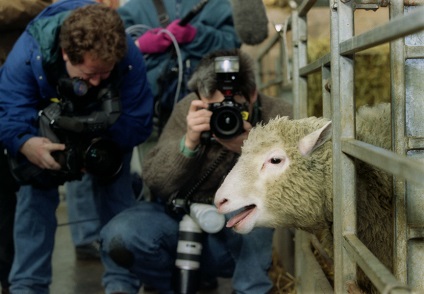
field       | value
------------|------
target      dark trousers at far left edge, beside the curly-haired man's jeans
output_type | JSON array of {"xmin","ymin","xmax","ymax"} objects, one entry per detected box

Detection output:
[{"xmin": 0, "ymin": 144, "xmax": 18, "ymax": 289}]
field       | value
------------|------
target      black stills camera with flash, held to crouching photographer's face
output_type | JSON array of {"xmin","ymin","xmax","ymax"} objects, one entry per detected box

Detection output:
[{"xmin": 202, "ymin": 56, "xmax": 249, "ymax": 142}]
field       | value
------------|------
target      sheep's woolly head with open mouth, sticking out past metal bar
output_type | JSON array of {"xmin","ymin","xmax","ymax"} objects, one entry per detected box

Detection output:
[{"xmin": 215, "ymin": 117, "xmax": 332, "ymax": 233}]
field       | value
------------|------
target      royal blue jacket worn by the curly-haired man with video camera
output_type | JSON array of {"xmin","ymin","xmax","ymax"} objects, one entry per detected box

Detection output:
[{"xmin": 0, "ymin": 0, "xmax": 153, "ymax": 156}]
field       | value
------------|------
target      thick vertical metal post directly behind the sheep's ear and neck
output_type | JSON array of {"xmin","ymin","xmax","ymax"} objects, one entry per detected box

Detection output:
[{"xmin": 330, "ymin": 0, "xmax": 356, "ymax": 293}]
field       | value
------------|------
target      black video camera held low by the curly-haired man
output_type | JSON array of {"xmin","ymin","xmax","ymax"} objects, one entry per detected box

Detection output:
[{"xmin": 9, "ymin": 78, "xmax": 122, "ymax": 188}]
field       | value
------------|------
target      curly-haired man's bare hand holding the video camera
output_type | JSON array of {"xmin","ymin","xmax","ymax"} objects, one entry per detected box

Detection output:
[{"xmin": 20, "ymin": 137, "xmax": 65, "ymax": 170}]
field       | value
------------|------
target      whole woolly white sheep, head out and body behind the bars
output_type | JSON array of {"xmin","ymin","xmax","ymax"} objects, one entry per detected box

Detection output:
[{"xmin": 215, "ymin": 103, "xmax": 393, "ymax": 292}]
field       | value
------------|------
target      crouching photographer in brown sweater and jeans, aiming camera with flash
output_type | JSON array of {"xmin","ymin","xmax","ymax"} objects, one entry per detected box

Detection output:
[{"xmin": 101, "ymin": 49, "xmax": 292, "ymax": 294}]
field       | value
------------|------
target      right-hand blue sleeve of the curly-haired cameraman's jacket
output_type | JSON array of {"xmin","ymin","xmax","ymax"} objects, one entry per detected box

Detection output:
[{"xmin": 109, "ymin": 36, "xmax": 153, "ymax": 151}]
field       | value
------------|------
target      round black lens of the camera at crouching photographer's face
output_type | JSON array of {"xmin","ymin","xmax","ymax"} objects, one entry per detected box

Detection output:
[{"xmin": 210, "ymin": 106, "xmax": 243, "ymax": 139}]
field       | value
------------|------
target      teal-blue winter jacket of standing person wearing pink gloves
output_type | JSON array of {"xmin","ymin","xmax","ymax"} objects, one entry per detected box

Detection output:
[{"xmin": 118, "ymin": 0, "xmax": 241, "ymax": 103}]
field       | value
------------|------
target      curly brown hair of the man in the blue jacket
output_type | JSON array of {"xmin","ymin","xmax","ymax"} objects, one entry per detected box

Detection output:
[{"xmin": 60, "ymin": 4, "xmax": 127, "ymax": 64}]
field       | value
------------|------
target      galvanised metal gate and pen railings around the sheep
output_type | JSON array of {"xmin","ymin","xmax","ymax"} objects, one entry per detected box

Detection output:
[{"xmin": 258, "ymin": 0, "xmax": 424, "ymax": 293}]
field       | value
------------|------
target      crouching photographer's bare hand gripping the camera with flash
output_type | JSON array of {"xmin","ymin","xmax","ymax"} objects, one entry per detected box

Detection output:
[{"xmin": 185, "ymin": 100, "xmax": 212, "ymax": 150}]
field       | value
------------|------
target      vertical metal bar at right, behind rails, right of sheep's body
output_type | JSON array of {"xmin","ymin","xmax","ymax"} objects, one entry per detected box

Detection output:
[{"xmin": 390, "ymin": 1, "xmax": 408, "ymax": 284}]
